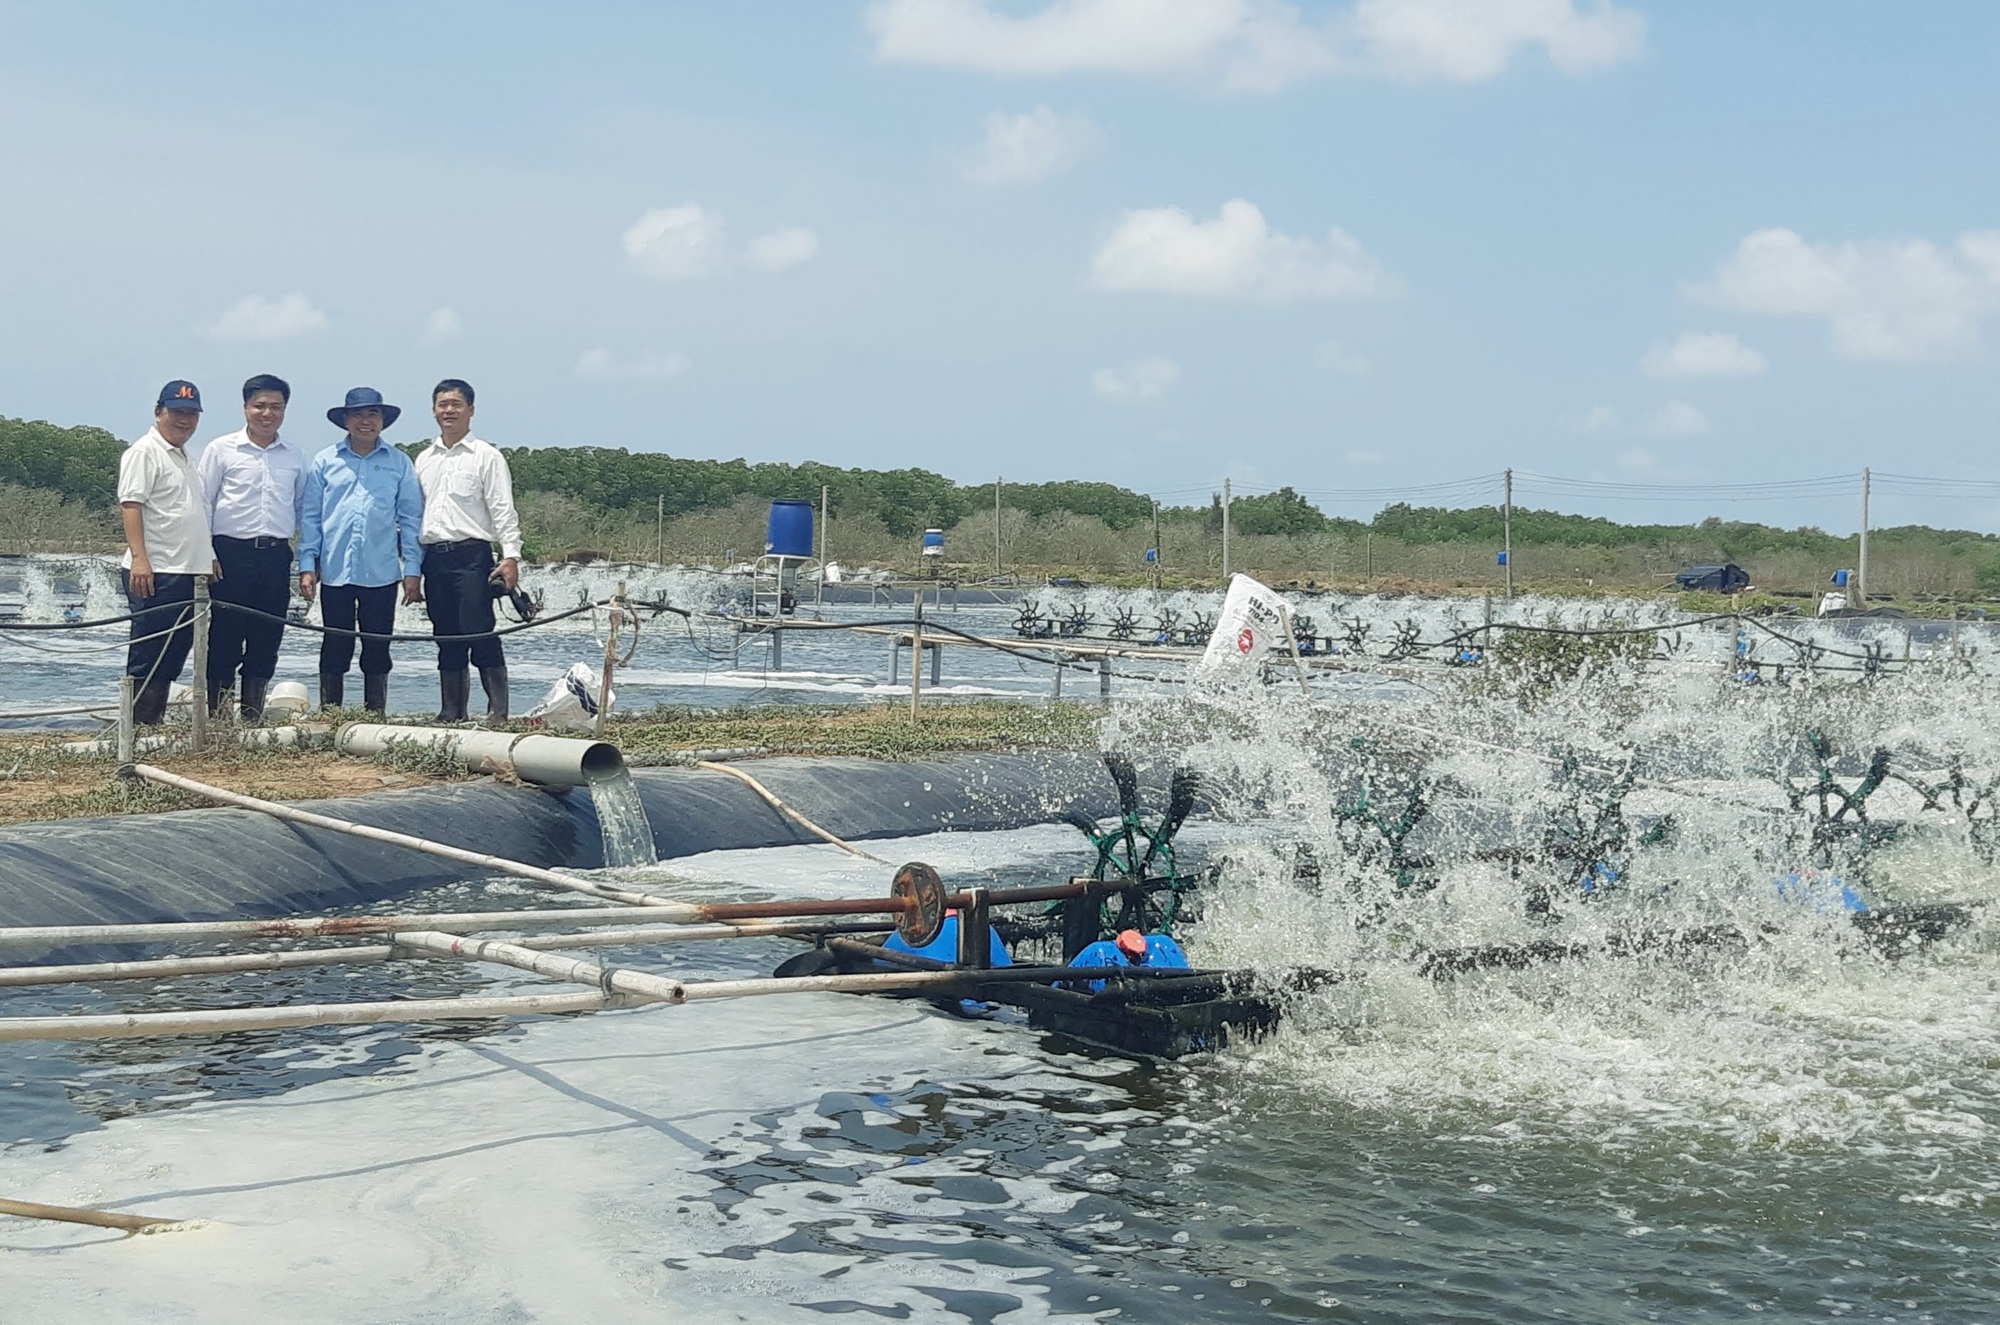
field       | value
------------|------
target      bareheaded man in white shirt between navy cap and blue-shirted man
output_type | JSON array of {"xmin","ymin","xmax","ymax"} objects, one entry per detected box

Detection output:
[{"xmin": 198, "ymin": 372, "xmax": 306, "ymax": 723}]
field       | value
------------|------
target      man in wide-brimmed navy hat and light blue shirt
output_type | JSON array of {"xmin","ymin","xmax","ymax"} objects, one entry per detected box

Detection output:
[{"xmin": 298, "ymin": 386, "xmax": 424, "ymax": 713}]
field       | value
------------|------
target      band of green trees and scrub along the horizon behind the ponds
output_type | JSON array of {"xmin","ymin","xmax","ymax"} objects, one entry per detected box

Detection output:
[{"xmin": 11, "ymin": 418, "xmax": 2000, "ymax": 598}]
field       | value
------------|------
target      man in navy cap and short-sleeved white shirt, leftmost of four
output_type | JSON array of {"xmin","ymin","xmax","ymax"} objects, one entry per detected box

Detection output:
[{"xmin": 118, "ymin": 380, "xmax": 222, "ymax": 727}]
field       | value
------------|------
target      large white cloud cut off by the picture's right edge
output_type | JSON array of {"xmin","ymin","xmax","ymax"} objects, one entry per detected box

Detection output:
[{"xmin": 1690, "ymin": 230, "xmax": 2000, "ymax": 360}]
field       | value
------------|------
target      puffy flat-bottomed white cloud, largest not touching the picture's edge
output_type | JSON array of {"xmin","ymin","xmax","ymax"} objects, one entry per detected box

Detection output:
[{"xmin": 1090, "ymin": 198, "xmax": 1392, "ymax": 300}]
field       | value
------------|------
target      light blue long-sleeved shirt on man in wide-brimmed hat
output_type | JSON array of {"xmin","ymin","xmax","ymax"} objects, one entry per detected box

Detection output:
[{"xmin": 298, "ymin": 442, "xmax": 424, "ymax": 586}]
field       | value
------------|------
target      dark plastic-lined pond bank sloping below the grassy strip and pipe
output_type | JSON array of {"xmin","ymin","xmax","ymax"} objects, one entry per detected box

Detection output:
[{"xmin": 0, "ymin": 751, "xmax": 1128, "ymax": 925}]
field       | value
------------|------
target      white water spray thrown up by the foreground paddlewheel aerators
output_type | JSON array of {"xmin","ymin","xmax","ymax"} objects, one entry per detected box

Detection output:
[{"xmin": 1104, "ymin": 628, "xmax": 2000, "ymax": 1168}]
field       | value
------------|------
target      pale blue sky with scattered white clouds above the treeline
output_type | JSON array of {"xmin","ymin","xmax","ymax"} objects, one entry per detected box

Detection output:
[{"xmin": 0, "ymin": 0, "xmax": 2000, "ymax": 528}]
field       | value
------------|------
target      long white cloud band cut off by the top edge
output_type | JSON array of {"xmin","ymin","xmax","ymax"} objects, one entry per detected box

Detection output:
[{"xmin": 868, "ymin": 0, "xmax": 1646, "ymax": 92}]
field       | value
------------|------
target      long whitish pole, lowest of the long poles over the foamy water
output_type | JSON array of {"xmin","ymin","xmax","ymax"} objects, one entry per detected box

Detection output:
[{"xmin": 0, "ymin": 989, "xmax": 626, "ymax": 1043}]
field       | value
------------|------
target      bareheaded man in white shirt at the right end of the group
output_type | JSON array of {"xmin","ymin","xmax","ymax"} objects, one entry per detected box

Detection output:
[{"xmin": 416, "ymin": 378, "xmax": 520, "ymax": 723}]
